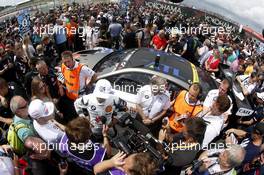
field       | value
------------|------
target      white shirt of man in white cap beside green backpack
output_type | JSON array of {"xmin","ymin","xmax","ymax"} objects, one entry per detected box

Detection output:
[{"xmin": 33, "ymin": 120, "xmax": 64, "ymax": 144}]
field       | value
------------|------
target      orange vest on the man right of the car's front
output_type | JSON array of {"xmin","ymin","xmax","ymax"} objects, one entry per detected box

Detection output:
[{"xmin": 169, "ymin": 90, "xmax": 203, "ymax": 132}]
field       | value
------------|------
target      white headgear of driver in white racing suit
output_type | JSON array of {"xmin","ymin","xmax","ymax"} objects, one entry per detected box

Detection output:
[{"xmin": 93, "ymin": 79, "xmax": 114, "ymax": 99}]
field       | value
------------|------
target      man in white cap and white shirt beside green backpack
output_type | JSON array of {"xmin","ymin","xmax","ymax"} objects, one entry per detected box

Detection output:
[{"xmin": 28, "ymin": 99, "xmax": 64, "ymax": 145}]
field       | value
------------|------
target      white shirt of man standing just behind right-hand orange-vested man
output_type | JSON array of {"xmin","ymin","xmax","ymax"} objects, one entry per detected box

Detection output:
[{"xmin": 203, "ymin": 89, "xmax": 233, "ymax": 115}]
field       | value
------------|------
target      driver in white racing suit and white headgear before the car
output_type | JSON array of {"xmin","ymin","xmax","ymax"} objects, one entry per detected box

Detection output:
[{"xmin": 74, "ymin": 79, "xmax": 125, "ymax": 136}]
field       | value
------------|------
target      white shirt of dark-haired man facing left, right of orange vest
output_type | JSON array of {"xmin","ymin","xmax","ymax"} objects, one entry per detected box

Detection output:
[{"xmin": 202, "ymin": 113, "xmax": 224, "ymax": 148}]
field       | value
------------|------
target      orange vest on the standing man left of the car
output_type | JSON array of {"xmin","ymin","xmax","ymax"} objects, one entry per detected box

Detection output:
[{"xmin": 61, "ymin": 64, "xmax": 83, "ymax": 100}]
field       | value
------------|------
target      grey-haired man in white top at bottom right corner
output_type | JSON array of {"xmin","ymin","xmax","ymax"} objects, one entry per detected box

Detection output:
[{"xmin": 186, "ymin": 144, "xmax": 246, "ymax": 175}]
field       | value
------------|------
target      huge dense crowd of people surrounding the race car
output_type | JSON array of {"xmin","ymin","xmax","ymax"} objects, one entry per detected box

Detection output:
[{"xmin": 0, "ymin": 3, "xmax": 264, "ymax": 175}]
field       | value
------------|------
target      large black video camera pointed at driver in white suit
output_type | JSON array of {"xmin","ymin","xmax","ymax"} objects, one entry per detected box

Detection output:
[{"xmin": 111, "ymin": 113, "xmax": 164, "ymax": 166}]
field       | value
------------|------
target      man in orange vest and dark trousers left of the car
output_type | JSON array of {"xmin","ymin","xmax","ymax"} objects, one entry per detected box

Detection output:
[{"xmin": 57, "ymin": 51, "xmax": 96, "ymax": 121}]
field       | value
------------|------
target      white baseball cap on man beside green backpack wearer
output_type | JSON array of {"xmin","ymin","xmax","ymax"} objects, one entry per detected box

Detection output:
[{"xmin": 28, "ymin": 99, "xmax": 55, "ymax": 119}]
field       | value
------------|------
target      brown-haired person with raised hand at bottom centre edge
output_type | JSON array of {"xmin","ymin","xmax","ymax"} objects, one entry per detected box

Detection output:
[{"xmin": 94, "ymin": 152, "xmax": 158, "ymax": 175}]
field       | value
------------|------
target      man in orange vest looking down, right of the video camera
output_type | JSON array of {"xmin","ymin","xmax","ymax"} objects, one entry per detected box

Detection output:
[{"xmin": 169, "ymin": 83, "xmax": 203, "ymax": 133}]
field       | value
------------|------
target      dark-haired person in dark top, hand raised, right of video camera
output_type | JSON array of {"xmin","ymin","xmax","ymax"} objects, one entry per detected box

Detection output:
[{"xmin": 159, "ymin": 118, "xmax": 206, "ymax": 175}]
